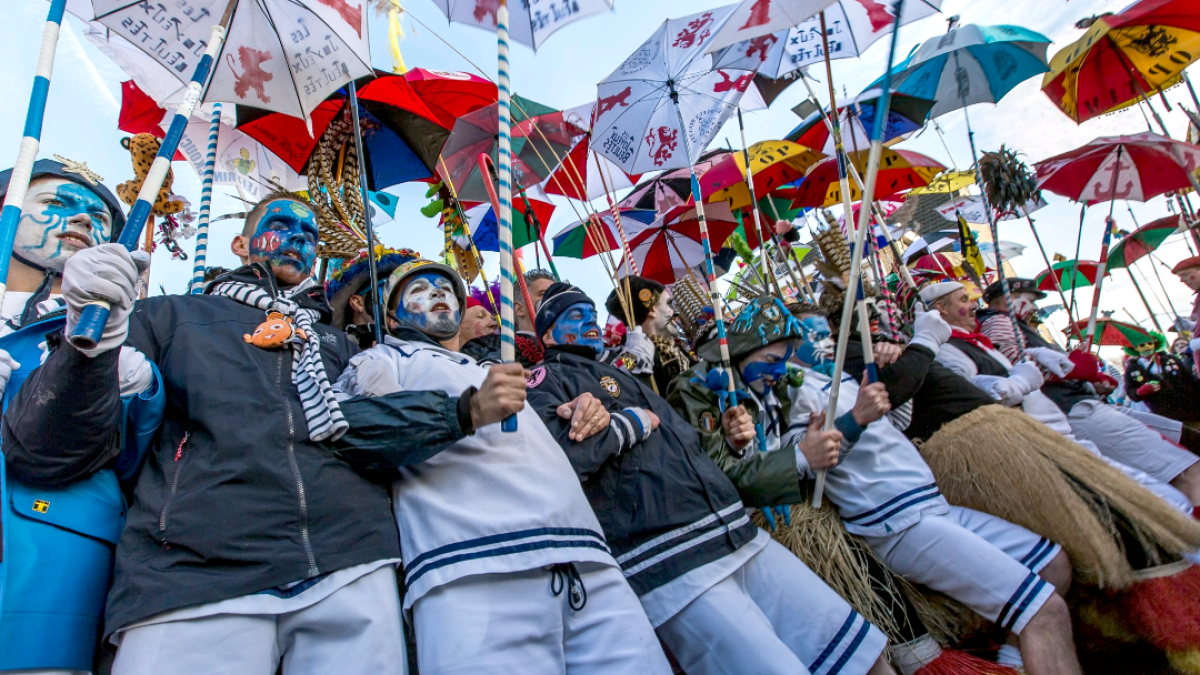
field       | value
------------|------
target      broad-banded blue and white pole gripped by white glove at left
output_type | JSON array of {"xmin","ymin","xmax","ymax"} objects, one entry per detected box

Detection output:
[{"xmin": 70, "ymin": 6, "xmax": 238, "ymax": 350}]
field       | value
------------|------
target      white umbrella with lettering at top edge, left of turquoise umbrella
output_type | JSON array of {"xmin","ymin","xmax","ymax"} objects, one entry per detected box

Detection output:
[{"xmin": 713, "ymin": 0, "xmax": 942, "ymax": 77}]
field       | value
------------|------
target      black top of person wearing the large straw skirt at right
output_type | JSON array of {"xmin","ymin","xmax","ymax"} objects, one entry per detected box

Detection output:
[{"xmin": 844, "ymin": 336, "xmax": 996, "ymax": 438}]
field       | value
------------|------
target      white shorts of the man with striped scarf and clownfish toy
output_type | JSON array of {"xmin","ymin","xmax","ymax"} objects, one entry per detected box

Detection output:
[{"xmin": 113, "ymin": 565, "xmax": 408, "ymax": 675}]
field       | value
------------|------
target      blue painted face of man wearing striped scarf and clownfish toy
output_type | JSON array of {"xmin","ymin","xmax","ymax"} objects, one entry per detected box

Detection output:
[{"xmin": 250, "ymin": 199, "xmax": 320, "ymax": 278}]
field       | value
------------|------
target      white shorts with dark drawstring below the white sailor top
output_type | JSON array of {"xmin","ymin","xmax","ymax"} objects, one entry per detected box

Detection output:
[{"xmin": 413, "ymin": 562, "xmax": 671, "ymax": 675}]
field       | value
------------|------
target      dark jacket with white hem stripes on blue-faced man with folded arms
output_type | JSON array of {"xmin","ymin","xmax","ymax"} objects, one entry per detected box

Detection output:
[{"xmin": 529, "ymin": 347, "xmax": 757, "ymax": 596}]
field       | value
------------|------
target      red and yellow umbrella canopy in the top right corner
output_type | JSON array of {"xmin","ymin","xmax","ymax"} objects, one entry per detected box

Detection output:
[{"xmin": 1042, "ymin": 0, "xmax": 1200, "ymax": 123}]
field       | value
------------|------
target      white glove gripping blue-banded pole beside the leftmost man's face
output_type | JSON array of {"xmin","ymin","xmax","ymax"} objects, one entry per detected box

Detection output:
[{"xmin": 62, "ymin": 244, "xmax": 150, "ymax": 357}]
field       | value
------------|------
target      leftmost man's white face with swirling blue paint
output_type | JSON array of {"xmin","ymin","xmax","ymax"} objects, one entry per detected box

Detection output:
[{"xmin": 13, "ymin": 178, "xmax": 113, "ymax": 271}]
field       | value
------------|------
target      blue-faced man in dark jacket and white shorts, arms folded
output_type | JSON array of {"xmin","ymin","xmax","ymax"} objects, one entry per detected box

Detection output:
[{"xmin": 529, "ymin": 283, "xmax": 892, "ymax": 675}]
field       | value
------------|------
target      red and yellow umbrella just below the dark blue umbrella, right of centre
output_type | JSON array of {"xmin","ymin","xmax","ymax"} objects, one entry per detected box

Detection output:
[{"xmin": 792, "ymin": 148, "xmax": 946, "ymax": 208}]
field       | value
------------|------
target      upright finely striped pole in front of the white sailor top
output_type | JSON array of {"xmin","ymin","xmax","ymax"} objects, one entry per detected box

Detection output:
[{"xmin": 496, "ymin": 0, "xmax": 517, "ymax": 431}]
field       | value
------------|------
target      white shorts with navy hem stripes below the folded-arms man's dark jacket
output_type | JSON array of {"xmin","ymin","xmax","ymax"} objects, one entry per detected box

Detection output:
[{"xmin": 659, "ymin": 539, "xmax": 887, "ymax": 675}]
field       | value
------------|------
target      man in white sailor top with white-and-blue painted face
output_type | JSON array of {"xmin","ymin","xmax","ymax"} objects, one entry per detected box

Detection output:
[{"xmin": 337, "ymin": 259, "xmax": 670, "ymax": 675}]
